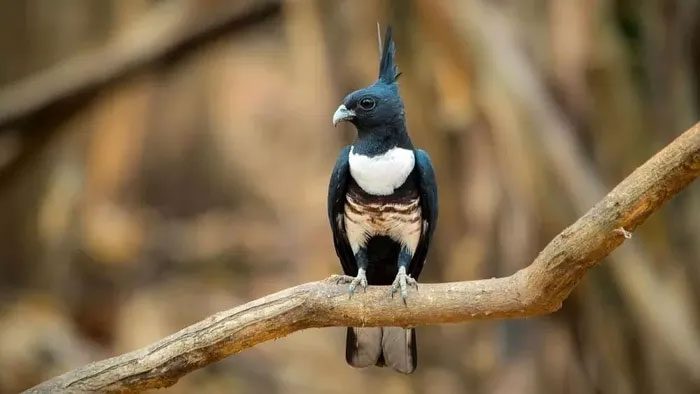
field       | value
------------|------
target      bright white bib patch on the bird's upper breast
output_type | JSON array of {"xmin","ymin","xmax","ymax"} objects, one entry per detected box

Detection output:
[{"xmin": 349, "ymin": 147, "xmax": 416, "ymax": 196}]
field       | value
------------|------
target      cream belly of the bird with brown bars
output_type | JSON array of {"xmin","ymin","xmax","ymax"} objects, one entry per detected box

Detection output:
[{"xmin": 344, "ymin": 193, "xmax": 422, "ymax": 255}]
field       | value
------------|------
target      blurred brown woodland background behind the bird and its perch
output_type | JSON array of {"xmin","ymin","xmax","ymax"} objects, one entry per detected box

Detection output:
[{"xmin": 0, "ymin": 0, "xmax": 700, "ymax": 394}]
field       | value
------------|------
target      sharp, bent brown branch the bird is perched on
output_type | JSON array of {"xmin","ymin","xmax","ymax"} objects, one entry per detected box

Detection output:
[{"xmin": 29, "ymin": 123, "xmax": 700, "ymax": 392}]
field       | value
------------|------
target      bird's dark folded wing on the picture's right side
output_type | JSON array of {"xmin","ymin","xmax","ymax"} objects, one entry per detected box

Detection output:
[{"xmin": 409, "ymin": 149, "xmax": 438, "ymax": 278}]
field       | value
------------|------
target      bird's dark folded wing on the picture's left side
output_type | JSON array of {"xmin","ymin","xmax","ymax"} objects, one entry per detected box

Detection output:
[{"xmin": 328, "ymin": 145, "xmax": 357, "ymax": 276}]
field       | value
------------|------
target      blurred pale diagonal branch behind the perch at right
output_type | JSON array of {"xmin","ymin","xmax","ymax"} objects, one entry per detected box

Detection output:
[{"xmin": 434, "ymin": 0, "xmax": 700, "ymax": 380}]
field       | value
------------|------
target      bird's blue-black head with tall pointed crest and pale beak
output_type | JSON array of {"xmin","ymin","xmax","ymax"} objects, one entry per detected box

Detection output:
[{"xmin": 333, "ymin": 26, "xmax": 404, "ymax": 133}]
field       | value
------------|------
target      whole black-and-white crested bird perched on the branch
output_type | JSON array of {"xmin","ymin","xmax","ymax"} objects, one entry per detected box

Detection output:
[{"xmin": 328, "ymin": 27, "xmax": 438, "ymax": 373}]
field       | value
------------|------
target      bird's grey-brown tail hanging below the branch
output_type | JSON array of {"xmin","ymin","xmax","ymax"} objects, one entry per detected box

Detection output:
[{"xmin": 345, "ymin": 327, "xmax": 418, "ymax": 374}]
